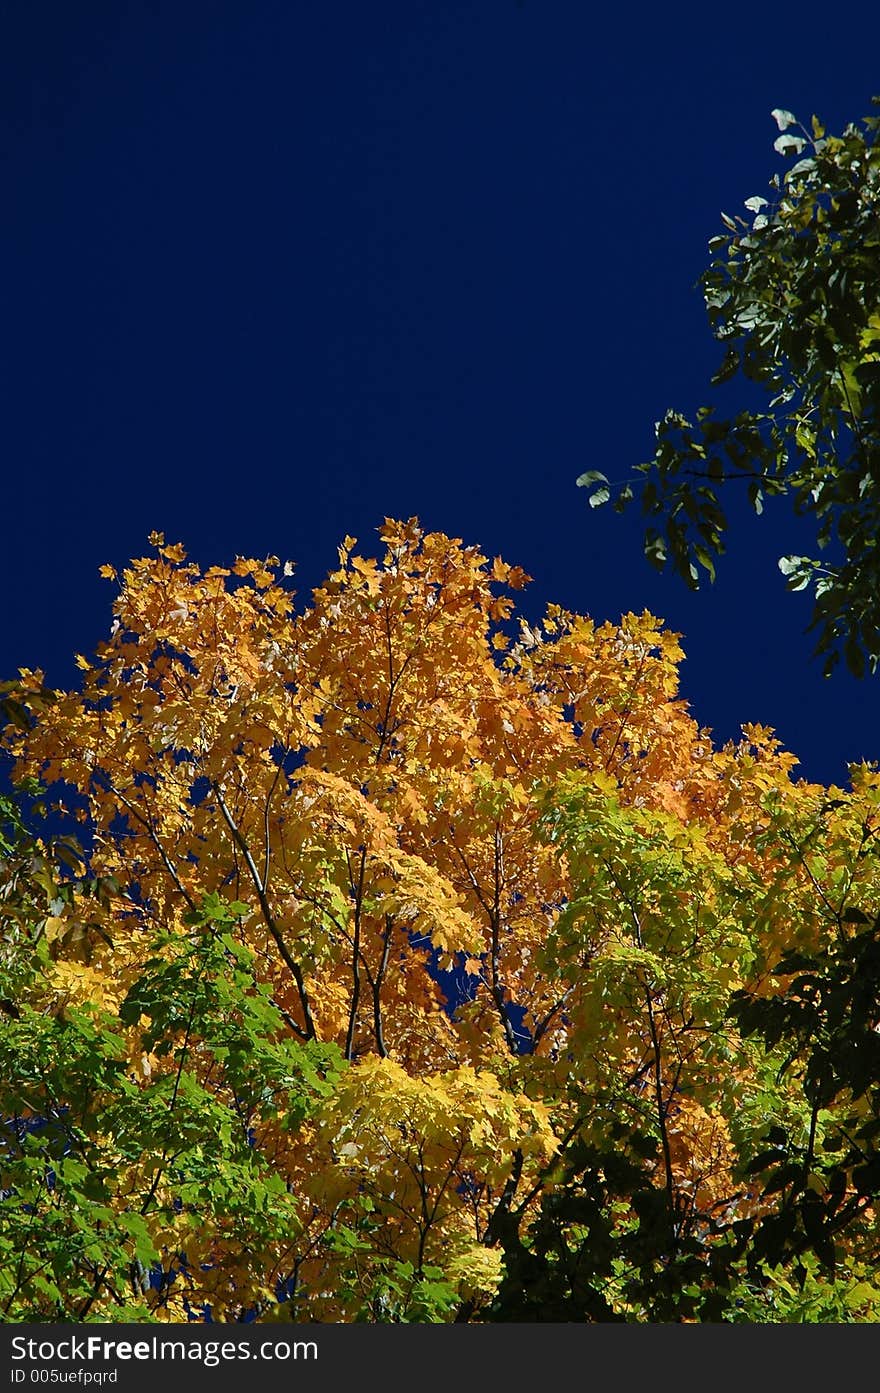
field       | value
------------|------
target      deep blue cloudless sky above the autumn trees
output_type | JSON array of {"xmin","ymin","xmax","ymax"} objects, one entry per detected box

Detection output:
[{"xmin": 0, "ymin": 0, "xmax": 880, "ymax": 781}]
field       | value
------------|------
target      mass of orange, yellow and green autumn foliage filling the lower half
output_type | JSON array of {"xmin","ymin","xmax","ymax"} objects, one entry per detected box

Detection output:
[{"xmin": 0, "ymin": 520, "xmax": 880, "ymax": 1322}]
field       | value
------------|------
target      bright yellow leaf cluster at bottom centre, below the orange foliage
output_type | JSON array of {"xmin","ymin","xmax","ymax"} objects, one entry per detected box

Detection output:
[{"xmin": 285, "ymin": 1056, "xmax": 557, "ymax": 1318}]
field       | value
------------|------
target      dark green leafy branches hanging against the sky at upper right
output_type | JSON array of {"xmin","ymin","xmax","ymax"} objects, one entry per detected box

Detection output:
[{"xmin": 578, "ymin": 99, "xmax": 880, "ymax": 677}]
